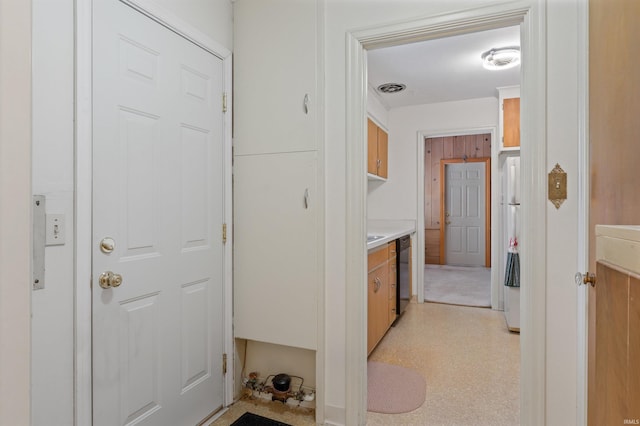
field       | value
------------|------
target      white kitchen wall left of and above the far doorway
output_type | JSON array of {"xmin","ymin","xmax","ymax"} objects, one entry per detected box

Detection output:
[{"xmin": 367, "ymin": 98, "xmax": 498, "ymax": 220}]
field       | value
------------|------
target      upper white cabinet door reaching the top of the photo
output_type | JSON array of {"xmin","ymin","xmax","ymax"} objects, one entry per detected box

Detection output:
[{"xmin": 233, "ymin": 0, "xmax": 319, "ymax": 155}]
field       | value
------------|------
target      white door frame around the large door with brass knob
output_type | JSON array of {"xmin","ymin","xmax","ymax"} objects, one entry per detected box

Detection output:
[{"xmin": 74, "ymin": 0, "xmax": 234, "ymax": 425}]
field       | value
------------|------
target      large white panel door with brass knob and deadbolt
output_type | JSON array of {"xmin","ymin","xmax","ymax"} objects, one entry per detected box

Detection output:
[{"xmin": 92, "ymin": 0, "xmax": 223, "ymax": 426}]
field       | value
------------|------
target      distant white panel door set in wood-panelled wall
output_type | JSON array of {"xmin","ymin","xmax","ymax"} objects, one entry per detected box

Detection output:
[{"xmin": 444, "ymin": 162, "xmax": 486, "ymax": 266}]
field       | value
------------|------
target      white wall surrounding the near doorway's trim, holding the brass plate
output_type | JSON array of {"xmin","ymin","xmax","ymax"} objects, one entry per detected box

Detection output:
[{"xmin": 325, "ymin": 0, "xmax": 577, "ymax": 424}]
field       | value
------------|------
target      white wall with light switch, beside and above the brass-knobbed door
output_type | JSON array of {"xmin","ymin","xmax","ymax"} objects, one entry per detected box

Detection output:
[{"xmin": 30, "ymin": 0, "xmax": 232, "ymax": 425}]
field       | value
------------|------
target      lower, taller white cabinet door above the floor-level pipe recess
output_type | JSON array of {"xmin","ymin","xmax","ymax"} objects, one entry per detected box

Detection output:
[{"xmin": 234, "ymin": 152, "xmax": 320, "ymax": 350}]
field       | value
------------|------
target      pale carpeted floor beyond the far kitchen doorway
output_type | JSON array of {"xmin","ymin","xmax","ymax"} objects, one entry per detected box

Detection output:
[{"xmin": 424, "ymin": 265, "xmax": 491, "ymax": 308}]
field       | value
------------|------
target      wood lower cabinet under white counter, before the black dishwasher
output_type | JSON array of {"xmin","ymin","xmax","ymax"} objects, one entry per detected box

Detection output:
[{"xmin": 367, "ymin": 241, "xmax": 397, "ymax": 354}]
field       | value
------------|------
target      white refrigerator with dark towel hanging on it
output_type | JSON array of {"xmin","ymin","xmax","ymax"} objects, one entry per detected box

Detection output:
[{"xmin": 502, "ymin": 156, "xmax": 520, "ymax": 332}]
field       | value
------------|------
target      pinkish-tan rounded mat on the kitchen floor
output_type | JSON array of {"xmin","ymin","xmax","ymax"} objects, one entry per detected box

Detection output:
[{"xmin": 367, "ymin": 361, "xmax": 427, "ymax": 414}]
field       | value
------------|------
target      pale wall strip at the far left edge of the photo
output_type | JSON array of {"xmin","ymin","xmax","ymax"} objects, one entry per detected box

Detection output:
[{"xmin": 0, "ymin": 0, "xmax": 31, "ymax": 425}]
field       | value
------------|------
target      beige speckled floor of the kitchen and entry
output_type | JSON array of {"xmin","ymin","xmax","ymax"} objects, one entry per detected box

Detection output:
[{"xmin": 212, "ymin": 303, "xmax": 520, "ymax": 426}]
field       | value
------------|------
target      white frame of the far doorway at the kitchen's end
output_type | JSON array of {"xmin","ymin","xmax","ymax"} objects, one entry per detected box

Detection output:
[{"xmin": 415, "ymin": 126, "xmax": 501, "ymax": 309}]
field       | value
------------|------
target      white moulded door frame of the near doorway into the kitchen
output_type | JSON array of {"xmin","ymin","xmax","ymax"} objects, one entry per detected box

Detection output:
[{"xmin": 346, "ymin": 0, "xmax": 547, "ymax": 425}]
